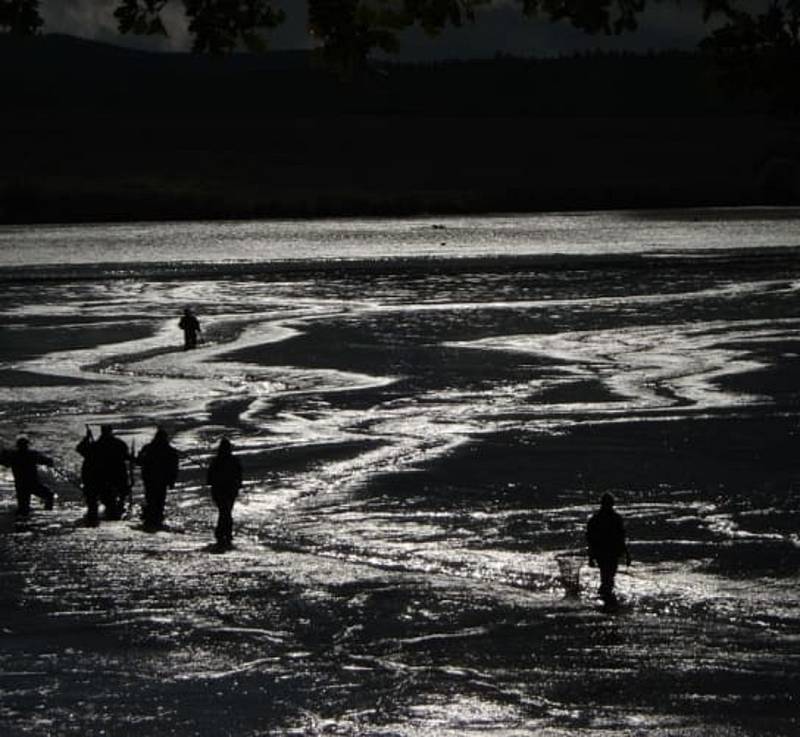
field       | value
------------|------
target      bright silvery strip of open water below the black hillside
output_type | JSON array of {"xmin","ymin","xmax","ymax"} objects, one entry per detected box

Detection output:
[{"xmin": 0, "ymin": 209, "xmax": 800, "ymax": 266}]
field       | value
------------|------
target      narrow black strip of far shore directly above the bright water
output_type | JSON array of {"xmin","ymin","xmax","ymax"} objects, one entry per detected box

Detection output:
[{"xmin": 0, "ymin": 173, "xmax": 800, "ymax": 226}]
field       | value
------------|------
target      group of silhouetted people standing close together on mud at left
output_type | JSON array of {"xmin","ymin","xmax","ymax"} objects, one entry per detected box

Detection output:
[{"xmin": 0, "ymin": 425, "xmax": 242, "ymax": 548}]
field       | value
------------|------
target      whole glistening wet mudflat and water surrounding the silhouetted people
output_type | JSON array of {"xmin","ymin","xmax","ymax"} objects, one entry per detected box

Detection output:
[{"xmin": 0, "ymin": 212, "xmax": 800, "ymax": 737}]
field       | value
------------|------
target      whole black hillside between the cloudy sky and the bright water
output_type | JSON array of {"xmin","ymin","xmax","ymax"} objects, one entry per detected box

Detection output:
[{"xmin": 0, "ymin": 36, "xmax": 800, "ymax": 223}]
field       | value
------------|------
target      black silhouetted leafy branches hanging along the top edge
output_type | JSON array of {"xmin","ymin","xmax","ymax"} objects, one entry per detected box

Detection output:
[{"xmin": 0, "ymin": 0, "xmax": 800, "ymax": 95}]
